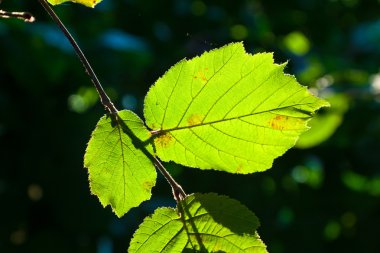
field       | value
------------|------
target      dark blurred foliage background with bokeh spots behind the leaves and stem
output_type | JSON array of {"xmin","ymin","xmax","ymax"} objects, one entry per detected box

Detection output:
[{"xmin": 0, "ymin": 0, "xmax": 380, "ymax": 253}]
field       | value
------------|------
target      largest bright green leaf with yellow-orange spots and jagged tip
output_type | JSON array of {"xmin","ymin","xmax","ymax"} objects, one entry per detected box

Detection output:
[{"xmin": 144, "ymin": 43, "xmax": 328, "ymax": 174}]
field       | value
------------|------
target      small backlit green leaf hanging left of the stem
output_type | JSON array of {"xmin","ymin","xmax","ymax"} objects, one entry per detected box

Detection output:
[{"xmin": 84, "ymin": 111, "xmax": 157, "ymax": 217}]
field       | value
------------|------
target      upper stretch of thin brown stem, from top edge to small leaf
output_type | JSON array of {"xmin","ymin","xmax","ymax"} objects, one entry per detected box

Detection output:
[{"xmin": 38, "ymin": 0, "xmax": 117, "ymax": 114}]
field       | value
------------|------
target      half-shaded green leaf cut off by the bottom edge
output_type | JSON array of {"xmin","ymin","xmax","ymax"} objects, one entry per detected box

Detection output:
[{"xmin": 128, "ymin": 193, "xmax": 267, "ymax": 253}]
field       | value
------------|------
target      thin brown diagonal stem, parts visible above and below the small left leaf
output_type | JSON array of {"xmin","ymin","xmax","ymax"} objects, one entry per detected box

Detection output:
[{"xmin": 36, "ymin": 0, "xmax": 186, "ymax": 202}]
